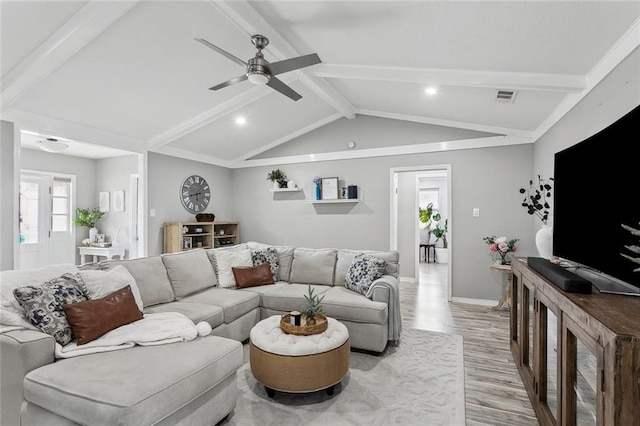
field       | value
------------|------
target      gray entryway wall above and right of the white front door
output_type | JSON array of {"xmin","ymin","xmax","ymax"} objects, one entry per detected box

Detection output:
[{"xmin": 20, "ymin": 149, "xmax": 98, "ymax": 263}]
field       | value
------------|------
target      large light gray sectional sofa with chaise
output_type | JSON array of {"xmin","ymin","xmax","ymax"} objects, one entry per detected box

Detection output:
[{"xmin": 0, "ymin": 242, "xmax": 402, "ymax": 425}]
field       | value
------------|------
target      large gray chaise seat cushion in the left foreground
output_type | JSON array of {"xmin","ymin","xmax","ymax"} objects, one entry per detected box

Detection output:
[{"xmin": 24, "ymin": 336, "xmax": 243, "ymax": 425}]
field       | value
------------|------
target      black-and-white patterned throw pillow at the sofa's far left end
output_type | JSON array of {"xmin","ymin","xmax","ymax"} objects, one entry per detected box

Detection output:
[{"xmin": 13, "ymin": 274, "xmax": 87, "ymax": 346}]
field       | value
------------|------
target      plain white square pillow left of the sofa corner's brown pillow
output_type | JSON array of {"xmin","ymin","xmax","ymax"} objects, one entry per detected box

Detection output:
[{"xmin": 160, "ymin": 249, "xmax": 218, "ymax": 300}]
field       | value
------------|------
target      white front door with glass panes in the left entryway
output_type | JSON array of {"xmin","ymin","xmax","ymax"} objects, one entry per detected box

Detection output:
[{"xmin": 19, "ymin": 172, "xmax": 75, "ymax": 269}]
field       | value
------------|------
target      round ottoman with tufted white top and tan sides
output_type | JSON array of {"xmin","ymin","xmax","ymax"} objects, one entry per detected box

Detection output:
[{"xmin": 249, "ymin": 315, "xmax": 350, "ymax": 397}]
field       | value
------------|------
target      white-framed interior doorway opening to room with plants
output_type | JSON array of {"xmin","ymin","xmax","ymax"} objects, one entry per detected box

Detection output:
[{"xmin": 390, "ymin": 164, "xmax": 453, "ymax": 301}]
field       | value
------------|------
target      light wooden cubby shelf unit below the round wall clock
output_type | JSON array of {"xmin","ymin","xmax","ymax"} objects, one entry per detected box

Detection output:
[{"xmin": 163, "ymin": 221, "xmax": 240, "ymax": 253}]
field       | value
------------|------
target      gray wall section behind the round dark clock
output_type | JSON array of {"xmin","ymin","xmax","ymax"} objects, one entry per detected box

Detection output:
[{"xmin": 147, "ymin": 152, "xmax": 234, "ymax": 256}]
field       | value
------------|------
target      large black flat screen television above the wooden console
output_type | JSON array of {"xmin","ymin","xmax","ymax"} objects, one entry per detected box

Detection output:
[{"xmin": 553, "ymin": 106, "xmax": 640, "ymax": 296}]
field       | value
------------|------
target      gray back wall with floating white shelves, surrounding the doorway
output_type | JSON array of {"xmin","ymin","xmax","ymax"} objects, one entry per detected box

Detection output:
[{"xmin": 233, "ymin": 136, "xmax": 535, "ymax": 300}]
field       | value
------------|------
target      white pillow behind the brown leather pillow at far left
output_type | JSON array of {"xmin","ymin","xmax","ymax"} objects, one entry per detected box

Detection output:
[{"xmin": 78, "ymin": 265, "xmax": 144, "ymax": 310}]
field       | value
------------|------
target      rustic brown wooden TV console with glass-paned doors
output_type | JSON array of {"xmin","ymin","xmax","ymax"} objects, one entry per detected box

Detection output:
[{"xmin": 510, "ymin": 259, "xmax": 640, "ymax": 426}]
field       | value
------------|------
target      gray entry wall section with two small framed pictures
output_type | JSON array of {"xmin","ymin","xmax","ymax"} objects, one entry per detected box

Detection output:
[{"xmin": 96, "ymin": 154, "xmax": 138, "ymax": 255}]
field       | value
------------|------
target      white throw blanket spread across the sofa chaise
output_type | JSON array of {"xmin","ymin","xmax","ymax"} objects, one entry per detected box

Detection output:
[{"xmin": 55, "ymin": 312, "xmax": 211, "ymax": 358}]
